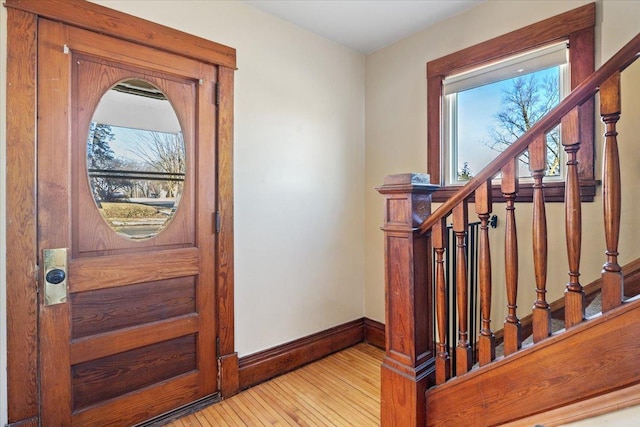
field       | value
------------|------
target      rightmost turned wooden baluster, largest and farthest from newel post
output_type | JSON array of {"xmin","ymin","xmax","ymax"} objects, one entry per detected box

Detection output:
[{"xmin": 600, "ymin": 72, "xmax": 624, "ymax": 313}]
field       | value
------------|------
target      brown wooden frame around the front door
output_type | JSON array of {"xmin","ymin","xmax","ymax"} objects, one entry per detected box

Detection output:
[{"xmin": 5, "ymin": 0, "xmax": 239, "ymax": 426}]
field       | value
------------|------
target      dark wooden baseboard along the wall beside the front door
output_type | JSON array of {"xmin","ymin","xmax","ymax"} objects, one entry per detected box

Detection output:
[{"xmin": 239, "ymin": 318, "xmax": 364, "ymax": 390}]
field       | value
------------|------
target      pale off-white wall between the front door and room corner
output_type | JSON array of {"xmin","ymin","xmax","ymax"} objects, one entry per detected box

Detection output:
[{"xmin": 90, "ymin": 1, "xmax": 364, "ymax": 356}]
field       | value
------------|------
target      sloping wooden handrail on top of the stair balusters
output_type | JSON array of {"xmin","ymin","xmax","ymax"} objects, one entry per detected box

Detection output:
[{"xmin": 419, "ymin": 33, "xmax": 640, "ymax": 233}]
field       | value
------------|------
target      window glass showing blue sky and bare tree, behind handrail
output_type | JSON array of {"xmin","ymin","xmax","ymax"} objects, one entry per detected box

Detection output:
[{"xmin": 447, "ymin": 66, "xmax": 563, "ymax": 184}]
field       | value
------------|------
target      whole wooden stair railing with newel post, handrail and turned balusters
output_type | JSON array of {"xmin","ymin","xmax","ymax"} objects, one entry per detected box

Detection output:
[{"xmin": 379, "ymin": 34, "xmax": 640, "ymax": 426}]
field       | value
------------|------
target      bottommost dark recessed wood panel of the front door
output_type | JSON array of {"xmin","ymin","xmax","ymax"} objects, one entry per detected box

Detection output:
[{"xmin": 71, "ymin": 335, "xmax": 197, "ymax": 410}]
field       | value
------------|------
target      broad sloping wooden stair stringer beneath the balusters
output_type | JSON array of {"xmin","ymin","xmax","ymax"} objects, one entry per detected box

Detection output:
[{"xmin": 426, "ymin": 297, "xmax": 640, "ymax": 426}]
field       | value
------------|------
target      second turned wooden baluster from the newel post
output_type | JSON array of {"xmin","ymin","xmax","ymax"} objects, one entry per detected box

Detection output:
[{"xmin": 453, "ymin": 201, "xmax": 473, "ymax": 376}]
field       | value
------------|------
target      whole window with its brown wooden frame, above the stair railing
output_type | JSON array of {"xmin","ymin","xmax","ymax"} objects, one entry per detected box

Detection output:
[{"xmin": 427, "ymin": 4, "xmax": 595, "ymax": 201}]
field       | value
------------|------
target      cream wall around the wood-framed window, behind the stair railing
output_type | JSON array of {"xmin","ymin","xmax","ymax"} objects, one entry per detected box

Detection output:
[{"xmin": 365, "ymin": 0, "xmax": 640, "ymax": 329}]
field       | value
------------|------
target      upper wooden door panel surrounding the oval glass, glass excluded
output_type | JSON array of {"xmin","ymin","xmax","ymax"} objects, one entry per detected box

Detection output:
[{"xmin": 71, "ymin": 54, "xmax": 198, "ymax": 258}]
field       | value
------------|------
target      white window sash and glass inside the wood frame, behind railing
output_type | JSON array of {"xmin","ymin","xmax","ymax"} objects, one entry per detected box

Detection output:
[{"xmin": 442, "ymin": 42, "xmax": 568, "ymax": 185}]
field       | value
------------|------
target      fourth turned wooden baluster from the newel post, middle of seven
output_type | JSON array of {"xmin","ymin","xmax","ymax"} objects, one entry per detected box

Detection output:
[{"xmin": 501, "ymin": 159, "xmax": 522, "ymax": 355}]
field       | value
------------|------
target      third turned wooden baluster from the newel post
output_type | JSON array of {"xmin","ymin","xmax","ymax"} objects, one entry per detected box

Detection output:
[{"xmin": 476, "ymin": 180, "xmax": 496, "ymax": 366}]
